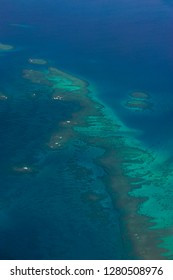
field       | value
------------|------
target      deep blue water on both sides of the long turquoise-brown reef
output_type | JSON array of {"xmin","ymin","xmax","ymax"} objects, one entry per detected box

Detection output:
[{"xmin": 0, "ymin": 0, "xmax": 173, "ymax": 259}]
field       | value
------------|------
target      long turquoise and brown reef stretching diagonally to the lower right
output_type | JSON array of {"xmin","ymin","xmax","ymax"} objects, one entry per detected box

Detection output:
[{"xmin": 23, "ymin": 62, "xmax": 173, "ymax": 259}]
